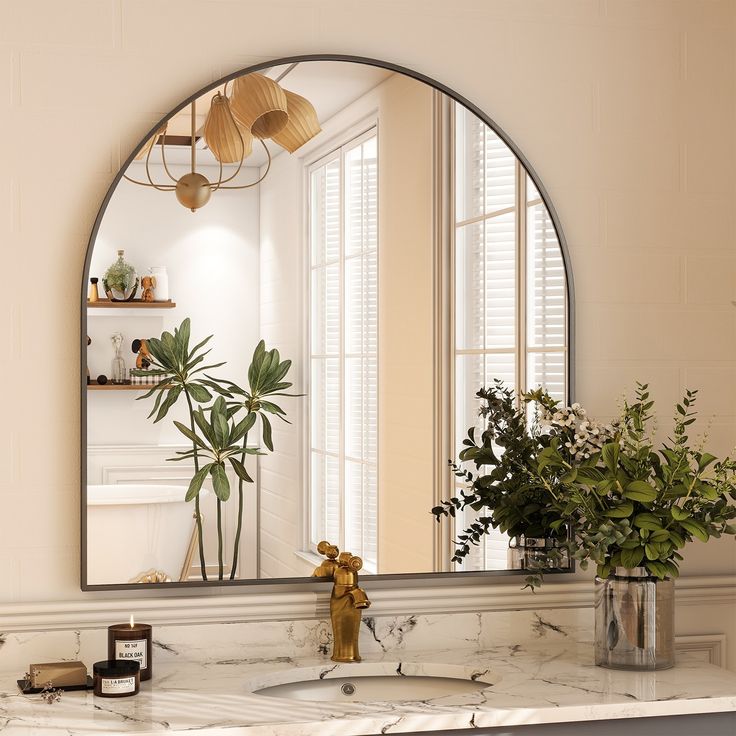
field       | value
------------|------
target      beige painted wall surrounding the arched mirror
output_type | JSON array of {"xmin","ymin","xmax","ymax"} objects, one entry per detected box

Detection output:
[{"xmin": 0, "ymin": 0, "xmax": 736, "ymax": 602}]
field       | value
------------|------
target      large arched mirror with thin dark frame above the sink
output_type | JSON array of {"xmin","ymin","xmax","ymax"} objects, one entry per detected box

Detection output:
[{"xmin": 82, "ymin": 57, "xmax": 572, "ymax": 589}]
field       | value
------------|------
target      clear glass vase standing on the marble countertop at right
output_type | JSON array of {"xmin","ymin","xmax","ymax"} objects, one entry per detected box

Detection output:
[{"xmin": 595, "ymin": 567, "xmax": 675, "ymax": 671}]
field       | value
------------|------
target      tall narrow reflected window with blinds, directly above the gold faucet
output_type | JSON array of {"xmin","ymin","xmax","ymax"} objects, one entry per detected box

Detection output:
[{"xmin": 308, "ymin": 128, "xmax": 378, "ymax": 572}]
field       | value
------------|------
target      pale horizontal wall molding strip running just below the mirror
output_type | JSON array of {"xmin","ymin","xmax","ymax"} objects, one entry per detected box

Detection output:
[{"xmin": 0, "ymin": 575, "xmax": 736, "ymax": 632}]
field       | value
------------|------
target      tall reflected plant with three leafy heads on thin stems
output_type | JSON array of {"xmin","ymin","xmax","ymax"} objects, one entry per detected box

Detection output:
[{"xmin": 134, "ymin": 318, "xmax": 292, "ymax": 580}]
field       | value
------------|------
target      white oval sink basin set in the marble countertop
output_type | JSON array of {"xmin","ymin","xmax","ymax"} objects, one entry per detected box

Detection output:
[{"xmin": 250, "ymin": 662, "xmax": 498, "ymax": 703}]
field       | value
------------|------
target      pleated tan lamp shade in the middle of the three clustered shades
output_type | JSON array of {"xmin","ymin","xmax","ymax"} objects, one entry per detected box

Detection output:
[{"xmin": 230, "ymin": 72, "xmax": 289, "ymax": 138}]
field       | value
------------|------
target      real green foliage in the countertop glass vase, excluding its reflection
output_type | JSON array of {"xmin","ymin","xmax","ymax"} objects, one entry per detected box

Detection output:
[{"xmin": 537, "ymin": 383, "xmax": 736, "ymax": 579}]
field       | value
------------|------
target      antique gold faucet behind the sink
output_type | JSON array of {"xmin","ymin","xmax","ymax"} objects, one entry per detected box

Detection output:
[{"xmin": 312, "ymin": 542, "xmax": 371, "ymax": 662}]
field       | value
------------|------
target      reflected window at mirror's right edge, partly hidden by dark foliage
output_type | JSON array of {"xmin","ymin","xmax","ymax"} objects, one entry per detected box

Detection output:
[{"xmin": 452, "ymin": 105, "xmax": 568, "ymax": 570}]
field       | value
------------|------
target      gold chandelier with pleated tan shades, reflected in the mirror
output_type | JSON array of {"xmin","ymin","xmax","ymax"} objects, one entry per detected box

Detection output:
[{"xmin": 123, "ymin": 65, "xmax": 321, "ymax": 212}]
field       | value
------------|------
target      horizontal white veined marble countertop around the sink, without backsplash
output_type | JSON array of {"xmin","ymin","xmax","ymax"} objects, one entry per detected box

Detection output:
[{"xmin": 0, "ymin": 636, "xmax": 736, "ymax": 736}]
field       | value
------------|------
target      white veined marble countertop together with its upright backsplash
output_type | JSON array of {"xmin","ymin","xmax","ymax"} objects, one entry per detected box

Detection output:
[{"xmin": 0, "ymin": 610, "xmax": 736, "ymax": 736}]
